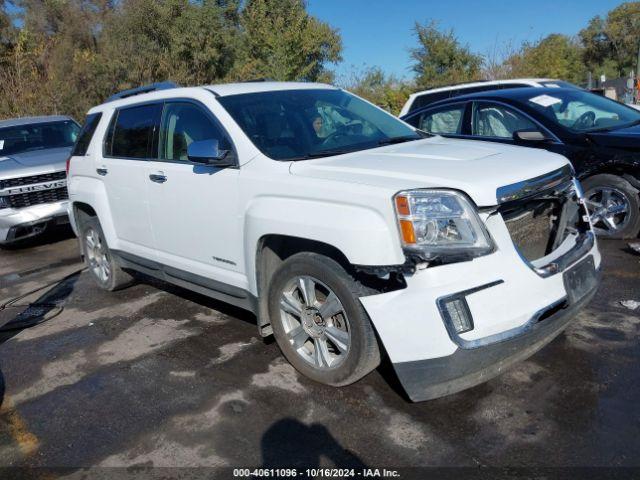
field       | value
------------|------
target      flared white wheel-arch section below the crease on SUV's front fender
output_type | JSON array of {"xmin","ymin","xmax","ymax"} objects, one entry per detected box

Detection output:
[{"xmin": 244, "ymin": 196, "xmax": 405, "ymax": 295}]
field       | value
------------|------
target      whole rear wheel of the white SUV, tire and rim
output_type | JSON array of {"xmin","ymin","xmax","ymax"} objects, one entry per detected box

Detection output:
[{"xmin": 80, "ymin": 217, "xmax": 133, "ymax": 292}]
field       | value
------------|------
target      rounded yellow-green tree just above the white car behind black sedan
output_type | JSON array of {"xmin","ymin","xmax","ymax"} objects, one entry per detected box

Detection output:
[{"xmin": 505, "ymin": 33, "xmax": 586, "ymax": 84}]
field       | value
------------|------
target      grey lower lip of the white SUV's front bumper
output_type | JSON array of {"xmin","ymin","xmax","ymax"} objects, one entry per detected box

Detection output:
[{"xmin": 393, "ymin": 281, "xmax": 599, "ymax": 402}]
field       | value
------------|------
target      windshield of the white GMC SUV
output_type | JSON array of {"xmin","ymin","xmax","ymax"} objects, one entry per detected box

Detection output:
[{"xmin": 218, "ymin": 89, "xmax": 423, "ymax": 160}]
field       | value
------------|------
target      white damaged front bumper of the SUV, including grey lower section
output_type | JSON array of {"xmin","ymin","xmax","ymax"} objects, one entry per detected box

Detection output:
[{"xmin": 360, "ymin": 215, "xmax": 601, "ymax": 401}]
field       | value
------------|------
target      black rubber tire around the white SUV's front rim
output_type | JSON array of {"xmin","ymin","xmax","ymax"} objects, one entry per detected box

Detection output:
[{"xmin": 268, "ymin": 253, "xmax": 380, "ymax": 386}]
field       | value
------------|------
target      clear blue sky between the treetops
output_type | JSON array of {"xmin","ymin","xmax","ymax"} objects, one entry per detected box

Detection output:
[{"xmin": 307, "ymin": 0, "xmax": 623, "ymax": 78}]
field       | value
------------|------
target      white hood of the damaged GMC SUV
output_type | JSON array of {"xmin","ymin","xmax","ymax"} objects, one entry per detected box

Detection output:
[{"xmin": 291, "ymin": 137, "xmax": 568, "ymax": 207}]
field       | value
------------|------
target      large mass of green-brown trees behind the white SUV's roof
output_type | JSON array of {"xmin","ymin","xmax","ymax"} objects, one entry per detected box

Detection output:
[{"xmin": 0, "ymin": 0, "xmax": 342, "ymax": 118}]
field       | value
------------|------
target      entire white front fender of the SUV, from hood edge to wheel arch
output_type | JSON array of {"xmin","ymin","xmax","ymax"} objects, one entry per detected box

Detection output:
[{"xmin": 243, "ymin": 163, "xmax": 405, "ymax": 294}]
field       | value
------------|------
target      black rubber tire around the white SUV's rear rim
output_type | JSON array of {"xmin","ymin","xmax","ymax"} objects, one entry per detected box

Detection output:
[{"xmin": 79, "ymin": 217, "xmax": 133, "ymax": 292}]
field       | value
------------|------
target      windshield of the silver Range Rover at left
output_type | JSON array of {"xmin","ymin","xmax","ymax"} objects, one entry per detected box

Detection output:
[{"xmin": 0, "ymin": 120, "xmax": 80, "ymax": 156}]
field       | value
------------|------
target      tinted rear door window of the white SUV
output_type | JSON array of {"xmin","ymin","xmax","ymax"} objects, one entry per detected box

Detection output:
[{"xmin": 107, "ymin": 104, "xmax": 162, "ymax": 158}]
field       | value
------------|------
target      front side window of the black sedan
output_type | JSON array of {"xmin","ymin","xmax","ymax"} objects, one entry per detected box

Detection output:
[{"xmin": 472, "ymin": 103, "xmax": 539, "ymax": 138}]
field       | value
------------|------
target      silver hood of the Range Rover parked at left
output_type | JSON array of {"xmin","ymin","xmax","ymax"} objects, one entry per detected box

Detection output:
[{"xmin": 0, "ymin": 147, "xmax": 72, "ymax": 178}]
